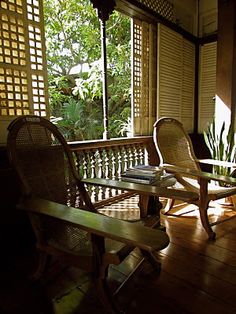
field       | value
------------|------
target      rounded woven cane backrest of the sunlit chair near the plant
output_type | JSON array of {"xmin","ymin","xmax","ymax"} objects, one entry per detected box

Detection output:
[{"xmin": 153, "ymin": 117, "xmax": 200, "ymax": 170}]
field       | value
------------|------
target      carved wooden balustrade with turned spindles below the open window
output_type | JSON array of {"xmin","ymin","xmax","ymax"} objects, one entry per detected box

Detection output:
[{"xmin": 69, "ymin": 136, "xmax": 159, "ymax": 205}]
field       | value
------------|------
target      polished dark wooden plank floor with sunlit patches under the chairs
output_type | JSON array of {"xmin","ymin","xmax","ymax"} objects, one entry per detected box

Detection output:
[{"xmin": 0, "ymin": 197, "xmax": 236, "ymax": 314}]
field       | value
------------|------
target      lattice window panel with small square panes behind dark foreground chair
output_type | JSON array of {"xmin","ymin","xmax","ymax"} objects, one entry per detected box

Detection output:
[{"xmin": 0, "ymin": 0, "xmax": 49, "ymax": 143}]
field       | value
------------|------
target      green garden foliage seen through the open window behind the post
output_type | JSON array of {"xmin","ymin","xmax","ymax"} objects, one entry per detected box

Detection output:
[{"xmin": 44, "ymin": 0, "xmax": 131, "ymax": 140}]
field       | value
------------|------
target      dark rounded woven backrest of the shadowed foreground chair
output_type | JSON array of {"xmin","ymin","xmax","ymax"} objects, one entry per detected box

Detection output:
[{"xmin": 7, "ymin": 116, "xmax": 95, "ymax": 207}]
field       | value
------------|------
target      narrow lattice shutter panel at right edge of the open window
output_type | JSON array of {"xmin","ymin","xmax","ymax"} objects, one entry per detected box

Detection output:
[{"xmin": 132, "ymin": 19, "xmax": 156, "ymax": 135}]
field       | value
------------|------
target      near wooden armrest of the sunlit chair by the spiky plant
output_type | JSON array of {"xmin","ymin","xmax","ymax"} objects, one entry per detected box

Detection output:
[{"xmin": 163, "ymin": 164, "xmax": 236, "ymax": 186}]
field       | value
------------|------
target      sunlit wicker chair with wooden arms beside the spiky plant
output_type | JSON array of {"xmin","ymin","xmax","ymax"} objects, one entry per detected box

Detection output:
[{"xmin": 153, "ymin": 117, "xmax": 236, "ymax": 239}]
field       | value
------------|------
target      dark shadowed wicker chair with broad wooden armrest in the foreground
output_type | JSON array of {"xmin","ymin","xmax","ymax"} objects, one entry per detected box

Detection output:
[{"xmin": 7, "ymin": 116, "xmax": 169, "ymax": 313}]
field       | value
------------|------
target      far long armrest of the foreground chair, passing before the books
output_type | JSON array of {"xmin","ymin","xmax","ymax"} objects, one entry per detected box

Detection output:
[{"xmin": 82, "ymin": 178, "xmax": 198, "ymax": 201}]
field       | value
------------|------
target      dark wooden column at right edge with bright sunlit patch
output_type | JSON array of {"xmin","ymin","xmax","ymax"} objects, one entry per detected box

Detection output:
[{"xmin": 216, "ymin": 0, "xmax": 236, "ymax": 129}]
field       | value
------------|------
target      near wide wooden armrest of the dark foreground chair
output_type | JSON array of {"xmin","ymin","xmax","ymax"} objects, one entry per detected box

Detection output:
[{"xmin": 17, "ymin": 198, "xmax": 169, "ymax": 252}]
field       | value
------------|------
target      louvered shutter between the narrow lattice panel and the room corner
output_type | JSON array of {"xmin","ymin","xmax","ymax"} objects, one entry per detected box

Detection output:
[{"xmin": 157, "ymin": 24, "xmax": 195, "ymax": 132}]
